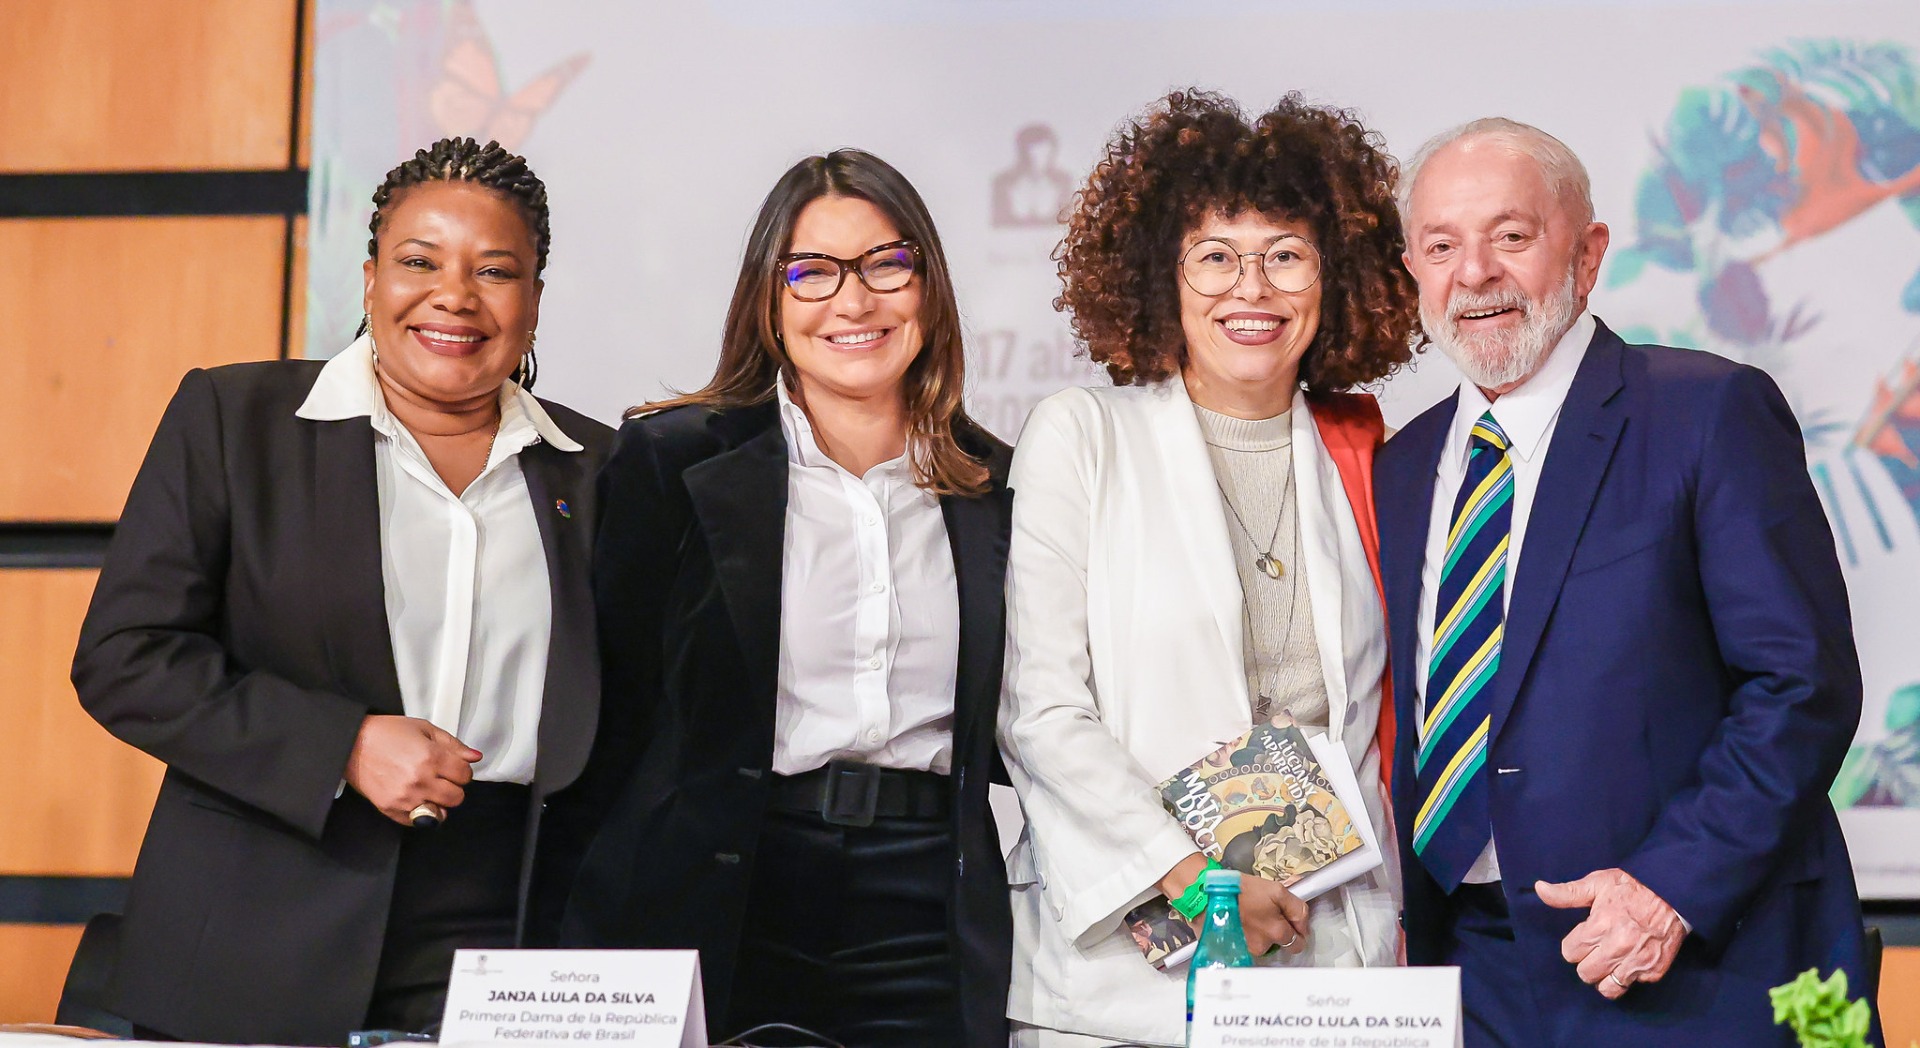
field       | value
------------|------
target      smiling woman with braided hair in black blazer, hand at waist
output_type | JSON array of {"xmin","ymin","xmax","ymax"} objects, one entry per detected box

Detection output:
[{"xmin": 73, "ymin": 138, "xmax": 612, "ymax": 1044}]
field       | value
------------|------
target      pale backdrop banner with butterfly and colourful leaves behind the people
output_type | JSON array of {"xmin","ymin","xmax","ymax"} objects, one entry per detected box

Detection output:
[{"xmin": 307, "ymin": 0, "xmax": 1920, "ymax": 898}]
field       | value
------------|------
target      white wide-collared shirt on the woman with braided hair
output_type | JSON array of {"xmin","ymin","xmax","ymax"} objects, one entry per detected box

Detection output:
[{"xmin": 298, "ymin": 336, "xmax": 582, "ymax": 783}]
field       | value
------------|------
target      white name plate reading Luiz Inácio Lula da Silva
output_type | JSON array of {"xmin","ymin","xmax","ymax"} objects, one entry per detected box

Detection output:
[{"xmin": 1188, "ymin": 967, "xmax": 1461, "ymax": 1048}]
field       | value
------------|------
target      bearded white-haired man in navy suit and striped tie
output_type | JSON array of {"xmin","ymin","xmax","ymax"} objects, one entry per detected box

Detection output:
[{"xmin": 1375, "ymin": 119, "xmax": 1878, "ymax": 1048}]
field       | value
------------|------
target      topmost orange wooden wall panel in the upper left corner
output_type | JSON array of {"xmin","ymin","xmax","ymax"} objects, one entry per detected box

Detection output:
[{"xmin": 0, "ymin": 0, "xmax": 298, "ymax": 171}]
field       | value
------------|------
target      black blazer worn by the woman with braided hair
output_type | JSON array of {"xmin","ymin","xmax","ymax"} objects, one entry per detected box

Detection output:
[{"xmin": 73, "ymin": 361, "xmax": 612, "ymax": 1044}]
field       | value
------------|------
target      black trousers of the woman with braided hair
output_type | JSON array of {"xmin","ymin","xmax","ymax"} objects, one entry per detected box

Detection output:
[{"xmin": 357, "ymin": 781, "xmax": 532, "ymax": 1042}]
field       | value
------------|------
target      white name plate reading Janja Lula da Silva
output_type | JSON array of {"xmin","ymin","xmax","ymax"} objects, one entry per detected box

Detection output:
[{"xmin": 440, "ymin": 950, "xmax": 707, "ymax": 1048}]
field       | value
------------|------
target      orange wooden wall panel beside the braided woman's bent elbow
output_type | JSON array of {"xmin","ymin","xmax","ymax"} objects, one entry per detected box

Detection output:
[{"xmin": 0, "ymin": 570, "xmax": 163, "ymax": 867}]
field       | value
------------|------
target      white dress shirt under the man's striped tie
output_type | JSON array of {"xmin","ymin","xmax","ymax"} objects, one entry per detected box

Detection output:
[{"xmin": 1413, "ymin": 311, "xmax": 1596, "ymax": 885}]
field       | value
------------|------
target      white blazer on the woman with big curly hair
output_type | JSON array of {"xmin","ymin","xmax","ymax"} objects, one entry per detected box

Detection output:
[{"xmin": 1000, "ymin": 376, "xmax": 1400, "ymax": 1044}]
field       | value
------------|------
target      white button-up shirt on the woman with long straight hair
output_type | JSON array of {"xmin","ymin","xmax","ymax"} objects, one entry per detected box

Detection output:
[{"xmin": 774, "ymin": 384, "xmax": 960, "ymax": 775}]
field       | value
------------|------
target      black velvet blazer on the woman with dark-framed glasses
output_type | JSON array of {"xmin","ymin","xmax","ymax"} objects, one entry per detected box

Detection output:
[{"xmin": 538, "ymin": 401, "xmax": 1012, "ymax": 1046}]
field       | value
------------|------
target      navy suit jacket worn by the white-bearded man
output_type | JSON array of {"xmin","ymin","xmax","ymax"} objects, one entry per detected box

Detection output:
[{"xmin": 1375, "ymin": 324, "xmax": 1864, "ymax": 1048}]
